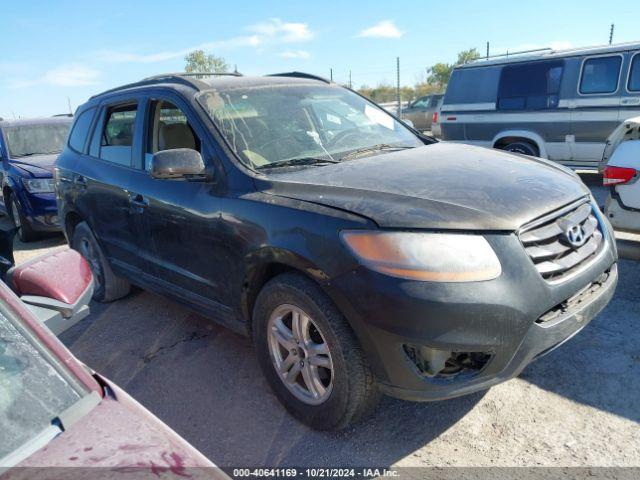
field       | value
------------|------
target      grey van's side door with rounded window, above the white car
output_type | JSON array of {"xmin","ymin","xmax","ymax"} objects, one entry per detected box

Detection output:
[{"xmin": 571, "ymin": 53, "xmax": 624, "ymax": 165}]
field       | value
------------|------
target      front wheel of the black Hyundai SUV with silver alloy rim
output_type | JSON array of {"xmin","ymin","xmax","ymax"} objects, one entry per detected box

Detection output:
[{"xmin": 253, "ymin": 273, "xmax": 379, "ymax": 430}]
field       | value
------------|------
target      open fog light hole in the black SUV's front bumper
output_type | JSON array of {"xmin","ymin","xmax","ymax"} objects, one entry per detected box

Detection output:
[{"xmin": 403, "ymin": 344, "xmax": 492, "ymax": 379}]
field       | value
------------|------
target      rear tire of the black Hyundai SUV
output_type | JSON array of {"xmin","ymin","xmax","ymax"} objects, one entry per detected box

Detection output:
[{"xmin": 71, "ymin": 222, "xmax": 131, "ymax": 303}]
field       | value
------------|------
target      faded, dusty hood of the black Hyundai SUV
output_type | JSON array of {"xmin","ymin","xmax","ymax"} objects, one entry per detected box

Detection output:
[{"xmin": 258, "ymin": 142, "xmax": 589, "ymax": 231}]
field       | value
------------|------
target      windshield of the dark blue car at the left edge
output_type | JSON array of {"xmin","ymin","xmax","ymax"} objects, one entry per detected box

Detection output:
[{"xmin": 5, "ymin": 122, "xmax": 71, "ymax": 157}]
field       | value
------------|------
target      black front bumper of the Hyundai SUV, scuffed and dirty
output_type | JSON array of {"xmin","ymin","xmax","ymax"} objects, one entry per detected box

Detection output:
[{"xmin": 330, "ymin": 231, "xmax": 617, "ymax": 401}]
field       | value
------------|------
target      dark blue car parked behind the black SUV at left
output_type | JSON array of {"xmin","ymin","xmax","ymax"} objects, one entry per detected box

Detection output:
[{"xmin": 0, "ymin": 116, "xmax": 72, "ymax": 242}]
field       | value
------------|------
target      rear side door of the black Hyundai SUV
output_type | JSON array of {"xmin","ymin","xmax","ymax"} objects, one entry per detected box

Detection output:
[{"xmin": 75, "ymin": 98, "xmax": 149, "ymax": 274}]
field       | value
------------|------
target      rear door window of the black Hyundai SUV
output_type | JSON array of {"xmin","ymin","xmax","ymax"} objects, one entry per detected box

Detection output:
[{"xmin": 100, "ymin": 104, "xmax": 138, "ymax": 167}]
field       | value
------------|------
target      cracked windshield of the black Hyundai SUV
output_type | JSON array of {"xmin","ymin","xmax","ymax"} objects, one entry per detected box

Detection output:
[{"xmin": 199, "ymin": 85, "xmax": 424, "ymax": 168}]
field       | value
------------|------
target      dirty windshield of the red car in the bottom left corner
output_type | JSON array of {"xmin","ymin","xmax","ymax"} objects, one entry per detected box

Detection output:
[{"xmin": 0, "ymin": 311, "xmax": 80, "ymax": 459}]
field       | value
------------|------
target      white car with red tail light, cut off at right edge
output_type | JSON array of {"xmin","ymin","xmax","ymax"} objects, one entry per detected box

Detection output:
[{"xmin": 601, "ymin": 117, "xmax": 640, "ymax": 233}]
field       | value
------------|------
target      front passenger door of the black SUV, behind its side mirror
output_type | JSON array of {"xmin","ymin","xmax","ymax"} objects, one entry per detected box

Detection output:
[{"xmin": 134, "ymin": 93, "xmax": 234, "ymax": 308}]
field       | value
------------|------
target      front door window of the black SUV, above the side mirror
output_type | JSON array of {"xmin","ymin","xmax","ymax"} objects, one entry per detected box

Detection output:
[{"xmin": 144, "ymin": 100, "xmax": 202, "ymax": 170}]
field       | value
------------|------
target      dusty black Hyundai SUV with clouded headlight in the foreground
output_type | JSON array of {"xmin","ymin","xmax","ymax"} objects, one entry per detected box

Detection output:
[{"xmin": 56, "ymin": 72, "xmax": 617, "ymax": 429}]
